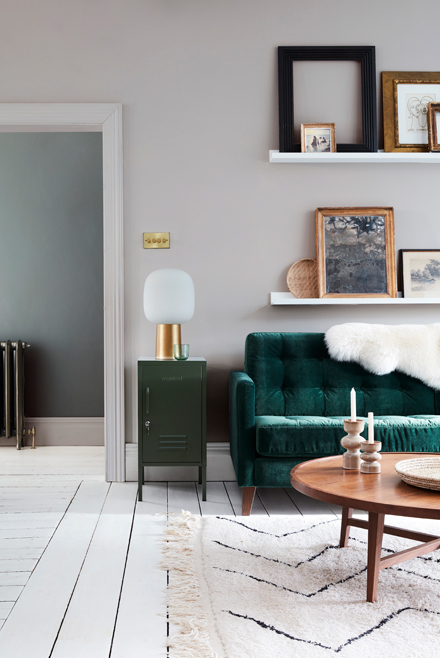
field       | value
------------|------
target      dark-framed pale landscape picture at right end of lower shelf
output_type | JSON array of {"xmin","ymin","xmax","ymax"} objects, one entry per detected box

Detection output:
[{"xmin": 400, "ymin": 249, "xmax": 440, "ymax": 299}]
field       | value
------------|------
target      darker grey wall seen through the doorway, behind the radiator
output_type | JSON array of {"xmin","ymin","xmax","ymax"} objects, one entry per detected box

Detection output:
[{"xmin": 0, "ymin": 133, "xmax": 104, "ymax": 417}]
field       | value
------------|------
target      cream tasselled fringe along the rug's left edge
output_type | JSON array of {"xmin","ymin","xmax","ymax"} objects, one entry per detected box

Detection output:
[{"xmin": 161, "ymin": 510, "xmax": 218, "ymax": 658}]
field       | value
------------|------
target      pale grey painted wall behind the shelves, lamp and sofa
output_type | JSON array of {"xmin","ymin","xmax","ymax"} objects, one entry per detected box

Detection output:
[{"xmin": 0, "ymin": 0, "xmax": 440, "ymax": 441}]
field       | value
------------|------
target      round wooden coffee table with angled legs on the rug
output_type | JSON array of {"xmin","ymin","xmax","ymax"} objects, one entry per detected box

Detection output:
[{"xmin": 290, "ymin": 452, "xmax": 440, "ymax": 602}]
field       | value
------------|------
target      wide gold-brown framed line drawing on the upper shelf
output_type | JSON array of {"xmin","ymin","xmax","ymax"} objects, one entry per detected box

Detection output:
[{"xmin": 382, "ymin": 71, "xmax": 440, "ymax": 153}]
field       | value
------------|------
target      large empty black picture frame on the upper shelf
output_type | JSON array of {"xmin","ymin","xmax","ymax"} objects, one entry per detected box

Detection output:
[{"xmin": 278, "ymin": 46, "xmax": 377, "ymax": 153}]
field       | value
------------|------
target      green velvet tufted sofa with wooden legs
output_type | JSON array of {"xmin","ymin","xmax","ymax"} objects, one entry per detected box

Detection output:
[{"xmin": 229, "ymin": 333, "xmax": 440, "ymax": 515}]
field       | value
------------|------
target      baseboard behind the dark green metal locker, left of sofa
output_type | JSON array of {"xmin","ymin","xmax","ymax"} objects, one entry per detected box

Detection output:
[{"xmin": 125, "ymin": 443, "xmax": 236, "ymax": 482}]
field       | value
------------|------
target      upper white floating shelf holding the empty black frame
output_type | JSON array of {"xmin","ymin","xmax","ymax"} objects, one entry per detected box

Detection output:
[{"xmin": 269, "ymin": 151, "xmax": 440, "ymax": 164}]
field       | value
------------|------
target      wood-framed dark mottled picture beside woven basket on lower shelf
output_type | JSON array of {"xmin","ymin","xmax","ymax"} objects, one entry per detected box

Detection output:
[{"xmin": 315, "ymin": 207, "xmax": 397, "ymax": 297}]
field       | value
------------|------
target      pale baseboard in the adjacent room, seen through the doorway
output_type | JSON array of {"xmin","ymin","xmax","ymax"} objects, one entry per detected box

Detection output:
[{"xmin": 0, "ymin": 417, "xmax": 104, "ymax": 447}]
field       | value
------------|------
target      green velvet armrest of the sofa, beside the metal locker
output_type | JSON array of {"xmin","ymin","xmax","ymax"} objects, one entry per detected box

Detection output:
[{"xmin": 229, "ymin": 370, "xmax": 256, "ymax": 487}]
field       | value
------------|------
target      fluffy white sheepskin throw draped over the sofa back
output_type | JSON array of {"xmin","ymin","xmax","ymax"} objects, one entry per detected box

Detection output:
[{"xmin": 325, "ymin": 322, "xmax": 440, "ymax": 389}]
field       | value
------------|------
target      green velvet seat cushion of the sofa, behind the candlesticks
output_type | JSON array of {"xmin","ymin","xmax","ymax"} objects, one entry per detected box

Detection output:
[{"xmin": 255, "ymin": 415, "xmax": 440, "ymax": 459}]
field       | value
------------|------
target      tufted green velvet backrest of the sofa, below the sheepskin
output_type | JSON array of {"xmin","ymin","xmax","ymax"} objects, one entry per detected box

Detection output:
[{"xmin": 245, "ymin": 333, "xmax": 440, "ymax": 418}]
